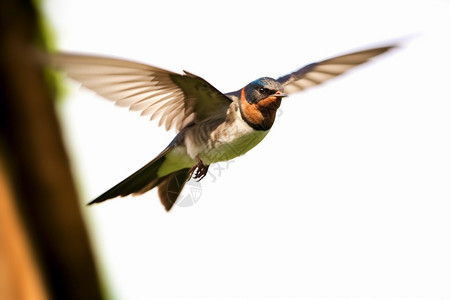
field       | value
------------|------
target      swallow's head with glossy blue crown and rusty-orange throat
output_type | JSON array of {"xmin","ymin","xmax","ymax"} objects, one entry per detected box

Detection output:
[{"xmin": 239, "ymin": 77, "xmax": 287, "ymax": 130}]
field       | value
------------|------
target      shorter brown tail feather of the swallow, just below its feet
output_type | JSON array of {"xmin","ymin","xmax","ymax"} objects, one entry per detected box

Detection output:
[{"xmin": 158, "ymin": 168, "xmax": 190, "ymax": 211}]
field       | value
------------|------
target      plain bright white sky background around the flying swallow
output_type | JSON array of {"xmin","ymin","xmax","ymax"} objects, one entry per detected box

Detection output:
[{"xmin": 46, "ymin": 0, "xmax": 450, "ymax": 300}]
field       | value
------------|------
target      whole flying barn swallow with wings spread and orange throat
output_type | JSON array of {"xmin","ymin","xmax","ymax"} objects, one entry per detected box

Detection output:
[{"xmin": 50, "ymin": 45, "xmax": 395, "ymax": 211}]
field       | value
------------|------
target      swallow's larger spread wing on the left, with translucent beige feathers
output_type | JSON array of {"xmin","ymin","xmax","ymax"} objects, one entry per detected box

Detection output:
[{"xmin": 49, "ymin": 53, "xmax": 231, "ymax": 131}]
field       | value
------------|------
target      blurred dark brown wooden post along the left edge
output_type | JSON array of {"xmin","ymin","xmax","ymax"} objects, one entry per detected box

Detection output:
[{"xmin": 0, "ymin": 0, "xmax": 101, "ymax": 300}]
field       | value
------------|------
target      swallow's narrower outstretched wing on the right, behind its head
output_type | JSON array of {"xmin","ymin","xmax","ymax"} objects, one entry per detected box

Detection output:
[{"xmin": 278, "ymin": 45, "xmax": 396, "ymax": 94}]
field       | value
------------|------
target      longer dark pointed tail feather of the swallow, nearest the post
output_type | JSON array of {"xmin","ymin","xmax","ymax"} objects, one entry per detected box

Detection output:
[{"xmin": 88, "ymin": 147, "xmax": 171, "ymax": 205}]
